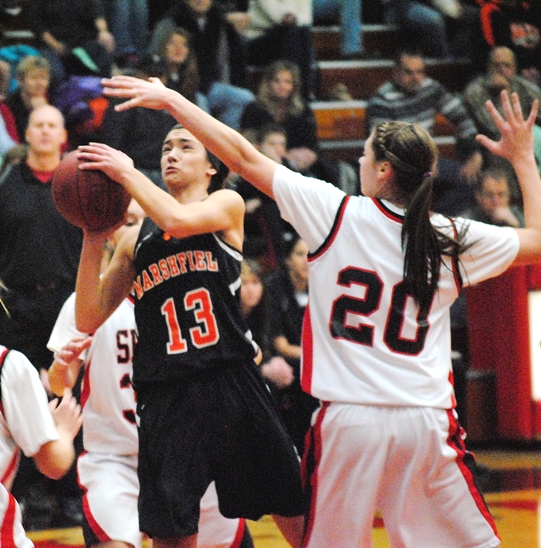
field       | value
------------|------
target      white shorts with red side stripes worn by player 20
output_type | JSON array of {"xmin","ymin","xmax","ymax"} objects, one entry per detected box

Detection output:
[{"xmin": 303, "ymin": 403, "xmax": 500, "ymax": 548}]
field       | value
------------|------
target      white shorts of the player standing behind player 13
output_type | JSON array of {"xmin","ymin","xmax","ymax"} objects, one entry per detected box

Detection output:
[{"xmin": 77, "ymin": 453, "xmax": 245, "ymax": 548}]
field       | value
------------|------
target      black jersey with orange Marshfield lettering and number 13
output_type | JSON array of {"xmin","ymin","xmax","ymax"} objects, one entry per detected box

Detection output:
[{"xmin": 133, "ymin": 218, "xmax": 255, "ymax": 385}]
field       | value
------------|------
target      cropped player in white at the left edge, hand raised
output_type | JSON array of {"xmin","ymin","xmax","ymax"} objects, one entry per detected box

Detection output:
[{"xmin": 0, "ymin": 345, "xmax": 82, "ymax": 548}]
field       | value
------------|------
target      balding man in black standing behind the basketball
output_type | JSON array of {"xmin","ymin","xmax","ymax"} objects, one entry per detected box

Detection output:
[{"xmin": 0, "ymin": 105, "xmax": 82, "ymax": 530}]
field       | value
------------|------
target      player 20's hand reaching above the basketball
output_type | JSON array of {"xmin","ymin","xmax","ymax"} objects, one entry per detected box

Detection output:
[{"xmin": 101, "ymin": 76, "xmax": 174, "ymax": 112}]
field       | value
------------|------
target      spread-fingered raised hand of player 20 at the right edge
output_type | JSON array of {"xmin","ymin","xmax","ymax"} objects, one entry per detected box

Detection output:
[{"xmin": 477, "ymin": 90, "xmax": 539, "ymax": 163}]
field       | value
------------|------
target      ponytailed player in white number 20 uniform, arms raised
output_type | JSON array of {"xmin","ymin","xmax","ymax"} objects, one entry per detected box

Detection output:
[{"xmin": 96, "ymin": 77, "xmax": 541, "ymax": 548}]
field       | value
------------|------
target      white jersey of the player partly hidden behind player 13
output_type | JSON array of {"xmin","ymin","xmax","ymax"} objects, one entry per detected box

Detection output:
[{"xmin": 48, "ymin": 293, "xmax": 138, "ymax": 455}]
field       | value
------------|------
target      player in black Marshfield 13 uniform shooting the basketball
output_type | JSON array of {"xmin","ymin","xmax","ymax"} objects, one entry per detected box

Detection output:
[{"xmin": 76, "ymin": 126, "xmax": 305, "ymax": 548}]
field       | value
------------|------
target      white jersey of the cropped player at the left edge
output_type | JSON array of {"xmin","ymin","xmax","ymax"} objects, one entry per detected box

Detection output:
[{"xmin": 0, "ymin": 345, "xmax": 58, "ymax": 489}]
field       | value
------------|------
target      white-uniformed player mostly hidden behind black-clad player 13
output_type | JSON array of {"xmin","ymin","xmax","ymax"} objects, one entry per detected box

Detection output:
[{"xmin": 48, "ymin": 200, "xmax": 253, "ymax": 548}]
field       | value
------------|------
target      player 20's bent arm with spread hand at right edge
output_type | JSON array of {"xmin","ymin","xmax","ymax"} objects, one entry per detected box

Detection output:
[{"xmin": 477, "ymin": 90, "xmax": 541, "ymax": 264}]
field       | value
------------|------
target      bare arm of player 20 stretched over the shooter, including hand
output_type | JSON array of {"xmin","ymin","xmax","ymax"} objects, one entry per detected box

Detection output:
[{"xmin": 102, "ymin": 76, "xmax": 277, "ymax": 198}]
